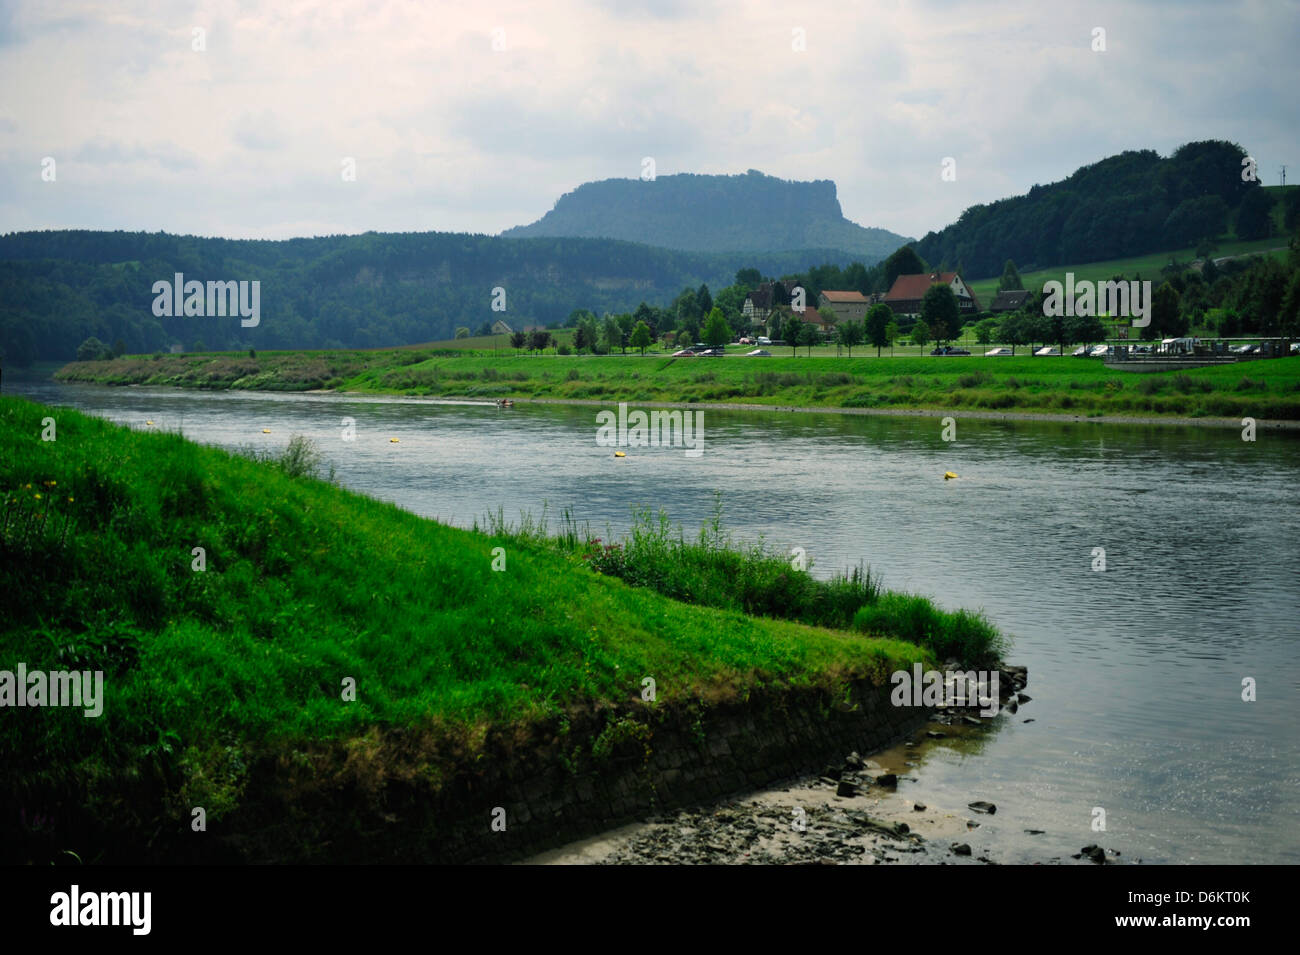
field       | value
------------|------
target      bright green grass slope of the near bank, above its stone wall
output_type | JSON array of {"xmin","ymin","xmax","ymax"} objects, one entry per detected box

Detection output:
[{"xmin": 0, "ymin": 398, "xmax": 993, "ymax": 861}]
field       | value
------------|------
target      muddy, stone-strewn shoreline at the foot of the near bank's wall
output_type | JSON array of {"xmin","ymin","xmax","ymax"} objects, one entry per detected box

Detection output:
[{"xmin": 521, "ymin": 683, "xmax": 1123, "ymax": 865}]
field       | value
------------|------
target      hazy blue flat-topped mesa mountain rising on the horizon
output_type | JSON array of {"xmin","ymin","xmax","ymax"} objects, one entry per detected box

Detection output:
[{"xmin": 502, "ymin": 169, "xmax": 910, "ymax": 264}]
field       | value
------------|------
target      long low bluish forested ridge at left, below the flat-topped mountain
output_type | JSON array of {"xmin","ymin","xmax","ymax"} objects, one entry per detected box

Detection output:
[{"xmin": 0, "ymin": 231, "xmax": 849, "ymax": 365}]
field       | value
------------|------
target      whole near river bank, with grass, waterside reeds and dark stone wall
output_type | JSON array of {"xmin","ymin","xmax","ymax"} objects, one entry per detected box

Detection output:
[{"xmin": 0, "ymin": 398, "xmax": 1000, "ymax": 863}]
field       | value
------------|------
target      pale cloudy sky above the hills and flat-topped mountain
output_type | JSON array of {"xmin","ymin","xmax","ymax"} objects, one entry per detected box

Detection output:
[{"xmin": 0, "ymin": 0, "xmax": 1300, "ymax": 239}]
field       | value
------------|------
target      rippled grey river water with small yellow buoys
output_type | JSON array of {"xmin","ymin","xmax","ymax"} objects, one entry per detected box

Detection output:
[{"xmin": 4, "ymin": 374, "xmax": 1300, "ymax": 864}]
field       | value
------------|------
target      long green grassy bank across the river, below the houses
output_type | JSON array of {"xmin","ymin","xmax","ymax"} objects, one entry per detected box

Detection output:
[{"xmin": 56, "ymin": 348, "xmax": 1300, "ymax": 421}]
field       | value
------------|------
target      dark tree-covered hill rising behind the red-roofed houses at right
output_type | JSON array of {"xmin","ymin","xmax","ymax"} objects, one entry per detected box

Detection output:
[{"xmin": 915, "ymin": 140, "xmax": 1273, "ymax": 279}]
